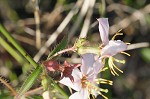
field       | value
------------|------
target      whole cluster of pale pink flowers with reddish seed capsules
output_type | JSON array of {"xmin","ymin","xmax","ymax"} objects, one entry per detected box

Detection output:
[{"xmin": 46, "ymin": 18, "xmax": 129, "ymax": 99}]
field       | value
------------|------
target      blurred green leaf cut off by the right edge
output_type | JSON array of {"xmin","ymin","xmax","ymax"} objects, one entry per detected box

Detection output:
[{"xmin": 141, "ymin": 48, "xmax": 150, "ymax": 63}]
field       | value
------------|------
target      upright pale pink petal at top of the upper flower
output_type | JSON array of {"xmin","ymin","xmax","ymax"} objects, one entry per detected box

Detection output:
[{"xmin": 97, "ymin": 18, "xmax": 109, "ymax": 45}]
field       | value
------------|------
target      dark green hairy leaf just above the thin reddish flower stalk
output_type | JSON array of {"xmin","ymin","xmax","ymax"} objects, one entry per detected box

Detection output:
[{"xmin": 47, "ymin": 37, "xmax": 68, "ymax": 59}]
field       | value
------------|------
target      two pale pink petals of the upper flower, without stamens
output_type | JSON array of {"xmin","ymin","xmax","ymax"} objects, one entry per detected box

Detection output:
[{"xmin": 97, "ymin": 18, "xmax": 127, "ymax": 56}]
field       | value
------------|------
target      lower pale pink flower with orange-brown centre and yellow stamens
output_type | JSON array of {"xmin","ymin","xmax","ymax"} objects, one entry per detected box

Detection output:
[{"xmin": 59, "ymin": 53, "xmax": 107, "ymax": 99}]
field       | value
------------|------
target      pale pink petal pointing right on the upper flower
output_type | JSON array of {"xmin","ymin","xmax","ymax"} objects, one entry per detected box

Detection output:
[{"xmin": 101, "ymin": 40, "xmax": 127, "ymax": 56}]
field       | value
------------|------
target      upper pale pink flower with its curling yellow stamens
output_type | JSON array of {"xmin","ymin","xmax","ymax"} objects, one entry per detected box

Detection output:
[{"xmin": 97, "ymin": 18, "xmax": 129, "ymax": 75}]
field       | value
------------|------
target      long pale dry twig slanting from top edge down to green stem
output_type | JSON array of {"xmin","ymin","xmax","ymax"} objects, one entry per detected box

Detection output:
[{"xmin": 34, "ymin": 0, "xmax": 82, "ymax": 61}]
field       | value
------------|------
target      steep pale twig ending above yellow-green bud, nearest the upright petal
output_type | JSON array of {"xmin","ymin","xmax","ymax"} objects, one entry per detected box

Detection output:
[{"xmin": 79, "ymin": 0, "xmax": 95, "ymax": 38}]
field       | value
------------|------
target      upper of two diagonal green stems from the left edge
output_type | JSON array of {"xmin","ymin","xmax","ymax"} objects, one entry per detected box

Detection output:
[{"xmin": 0, "ymin": 24, "xmax": 38, "ymax": 67}]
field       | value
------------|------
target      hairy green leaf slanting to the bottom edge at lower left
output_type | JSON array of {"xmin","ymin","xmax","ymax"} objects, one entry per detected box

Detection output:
[{"xmin": 16, "ymin": 66, "xmax": 42, "ymax": 99}]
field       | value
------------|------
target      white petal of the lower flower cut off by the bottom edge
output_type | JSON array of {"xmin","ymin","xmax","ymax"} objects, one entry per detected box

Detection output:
[{"xmin": 69, "ymin": 89, "xmax": 89, "ymax": 99}]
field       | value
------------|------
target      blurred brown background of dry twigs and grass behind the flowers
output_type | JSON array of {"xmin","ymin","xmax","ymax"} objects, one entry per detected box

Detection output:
[{"xmin": 0, "ymin": 0, "xmax": 150, "ymax": 99}]
